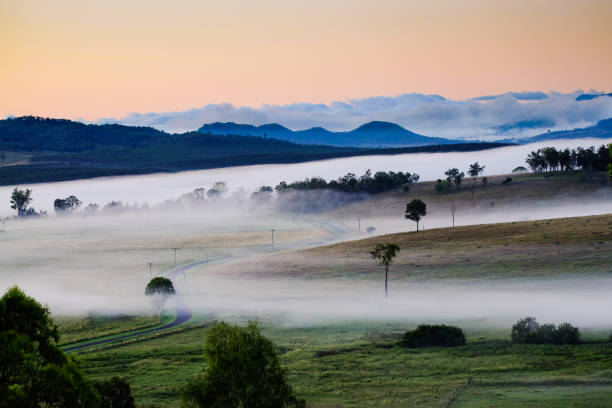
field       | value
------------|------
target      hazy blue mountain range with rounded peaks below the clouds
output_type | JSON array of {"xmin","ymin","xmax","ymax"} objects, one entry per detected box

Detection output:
[{"xmin": 198, "ymin": 121, "xmax": 466, "ymax": 147}]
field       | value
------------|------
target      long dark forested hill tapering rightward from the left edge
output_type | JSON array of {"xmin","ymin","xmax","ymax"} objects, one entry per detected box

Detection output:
[{"xmin": 0, "ymin": 117, "xmax": 510, "ymax": 185}]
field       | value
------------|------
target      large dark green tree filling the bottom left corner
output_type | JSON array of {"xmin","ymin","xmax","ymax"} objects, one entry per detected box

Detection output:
[{"xmin": 0, "ymin": 287, "xmax": 99, "ymax": 408}]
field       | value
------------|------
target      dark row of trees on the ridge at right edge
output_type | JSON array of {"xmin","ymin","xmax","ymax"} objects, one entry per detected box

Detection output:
[{"xmin": 525, "ymin": 145, "xmax": 610, "ymax": 173}]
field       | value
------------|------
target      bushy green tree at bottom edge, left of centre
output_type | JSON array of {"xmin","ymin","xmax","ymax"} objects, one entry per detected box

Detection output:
[{"xmin": 180, "ymin": 322, "xmax": 305, "ymax": 408}]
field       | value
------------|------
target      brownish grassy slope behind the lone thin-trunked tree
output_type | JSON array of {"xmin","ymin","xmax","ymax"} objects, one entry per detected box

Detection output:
[{"xmin": 214, "ymin": 214, "xmax": 612, "ymax": 281}]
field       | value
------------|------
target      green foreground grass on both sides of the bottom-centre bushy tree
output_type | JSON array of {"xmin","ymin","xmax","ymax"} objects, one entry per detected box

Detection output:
[{"xmin": 77, "ymin": 323, "xmax": 612, "ymax": 407}]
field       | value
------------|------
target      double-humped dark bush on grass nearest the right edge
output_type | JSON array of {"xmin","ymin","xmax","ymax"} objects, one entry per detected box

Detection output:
[{"xmin": 511, "ymin": 317, "xmax": 580, "ymax": 344}]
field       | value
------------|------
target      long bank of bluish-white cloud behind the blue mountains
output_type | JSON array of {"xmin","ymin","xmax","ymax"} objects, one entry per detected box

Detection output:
[{"xmin": 99, "ymin": 91, "xmax": 612, "ymax": 140}]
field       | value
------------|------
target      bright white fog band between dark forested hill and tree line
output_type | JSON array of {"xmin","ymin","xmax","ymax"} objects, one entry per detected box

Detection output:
[{"xmin": 0, "ymin": 139, "xmax": 612, "ymax": 217}]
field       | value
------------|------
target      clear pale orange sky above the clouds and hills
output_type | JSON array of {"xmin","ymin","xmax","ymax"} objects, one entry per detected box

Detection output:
[{"xmin": 0, "ymin": 0, "xmax": 612, "ymax": 119}]
